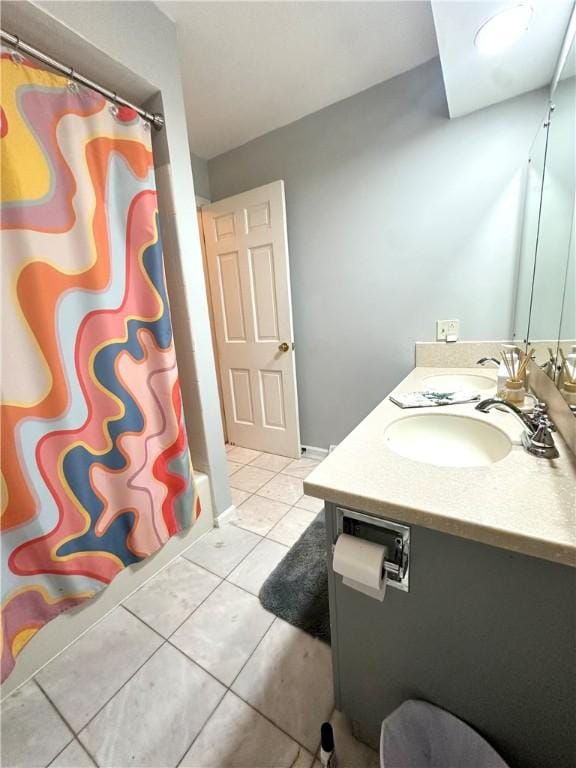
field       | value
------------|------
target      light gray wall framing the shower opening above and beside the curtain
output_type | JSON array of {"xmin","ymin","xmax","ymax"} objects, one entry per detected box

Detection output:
[{"xmin": 2, "ymin": 0, "xmax": 231, "ymax": 513}]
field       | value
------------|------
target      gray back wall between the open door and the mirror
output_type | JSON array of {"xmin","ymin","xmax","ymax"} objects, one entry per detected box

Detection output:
[{"xmin": 208, "ymin": 60, "xmax": 545, "ymax": 447}]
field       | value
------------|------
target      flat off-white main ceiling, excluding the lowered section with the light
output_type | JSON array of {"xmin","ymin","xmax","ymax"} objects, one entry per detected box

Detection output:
[{"xmin": 158, "ymin": 0, "xmax": 438, "ymax": 158}]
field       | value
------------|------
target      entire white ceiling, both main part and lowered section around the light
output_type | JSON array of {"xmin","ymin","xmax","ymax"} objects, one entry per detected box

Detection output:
[{"xmin": 157, "ymin": 0, "xmax": 574, "ymax": 158}]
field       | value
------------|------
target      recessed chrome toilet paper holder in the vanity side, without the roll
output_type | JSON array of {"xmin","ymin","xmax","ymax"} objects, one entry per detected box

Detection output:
[{"xmin": 332, "ymin": 507, "xmax": 410, "ymax": 592}]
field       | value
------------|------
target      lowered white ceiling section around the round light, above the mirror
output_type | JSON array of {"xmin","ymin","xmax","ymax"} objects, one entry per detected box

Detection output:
[{"xmin": 432, "ymin": 0, "xmax": 574, "ymax": 117}]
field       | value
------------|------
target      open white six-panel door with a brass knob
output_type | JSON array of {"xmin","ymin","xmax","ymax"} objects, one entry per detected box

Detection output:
[{"xmin": 202, "ymin": 181, "xmax": 300, "ymax": 458}]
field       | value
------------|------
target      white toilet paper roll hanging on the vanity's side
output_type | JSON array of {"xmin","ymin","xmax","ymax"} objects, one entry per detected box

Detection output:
[{"xmin": 332, "ymin": 533, "xmax": 386, "ymax": 601}]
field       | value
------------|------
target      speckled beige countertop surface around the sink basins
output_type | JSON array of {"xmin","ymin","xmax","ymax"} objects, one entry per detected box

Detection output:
[{"xmin": 304, "ymin": 367, "xmax": 576, "ymax": 567}]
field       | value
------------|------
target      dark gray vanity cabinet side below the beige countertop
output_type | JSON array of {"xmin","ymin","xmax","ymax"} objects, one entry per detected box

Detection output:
[{"xmin": 326, "ymin": 503, "xmax": 576, "ymax": 768}]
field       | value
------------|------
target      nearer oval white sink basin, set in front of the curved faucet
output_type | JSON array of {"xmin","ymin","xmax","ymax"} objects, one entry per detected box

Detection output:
[{"xmin": 384, "ymin": 413, "xmax": 512, "ymax": 467}]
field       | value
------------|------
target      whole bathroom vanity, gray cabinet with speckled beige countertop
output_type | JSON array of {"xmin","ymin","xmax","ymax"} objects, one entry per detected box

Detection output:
[{"xmin": 304, "ymin": 368, "xmax": 576, "ymax": 768}]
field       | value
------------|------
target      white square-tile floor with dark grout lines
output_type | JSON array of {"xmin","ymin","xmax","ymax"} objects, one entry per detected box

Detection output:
[{"xmin": 1, "ymin": 447, "xmax": 378, "ymax": 768}]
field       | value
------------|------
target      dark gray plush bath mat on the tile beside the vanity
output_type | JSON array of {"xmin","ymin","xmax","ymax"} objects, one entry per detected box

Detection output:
[{"xmin": 260, "ymin": 512, "xmax": 330, "ymax": 644}]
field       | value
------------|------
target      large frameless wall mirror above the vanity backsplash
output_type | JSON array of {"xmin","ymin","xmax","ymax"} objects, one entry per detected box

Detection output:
[{"xmin": 514, "ymin": 25, "xmax": 576, "ymax": 412}]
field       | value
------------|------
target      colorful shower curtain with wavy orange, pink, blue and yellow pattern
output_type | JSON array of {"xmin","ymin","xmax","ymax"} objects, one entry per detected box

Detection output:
[{"xmin": 0, "ymin": 49, "xmax": 199, "ymax": 679}]
